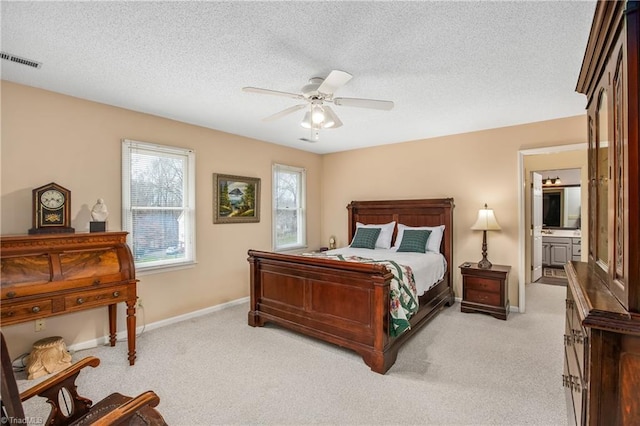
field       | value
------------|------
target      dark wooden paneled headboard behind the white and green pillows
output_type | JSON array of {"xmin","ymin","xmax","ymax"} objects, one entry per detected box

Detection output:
[{"xmin": 347, "ymin": 198, "xmax": 454, "ymax": 274}]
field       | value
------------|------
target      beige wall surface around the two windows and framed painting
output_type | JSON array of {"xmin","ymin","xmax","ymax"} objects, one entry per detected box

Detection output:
[{"xmin": 1, "ymin": 81, "xmax": 322, "ymax": 353}]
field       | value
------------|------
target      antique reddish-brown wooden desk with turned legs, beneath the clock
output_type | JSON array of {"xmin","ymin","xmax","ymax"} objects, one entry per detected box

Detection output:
[{"xmin": 0, "ymin": 232, "xmax": 137, "ymax": 365}]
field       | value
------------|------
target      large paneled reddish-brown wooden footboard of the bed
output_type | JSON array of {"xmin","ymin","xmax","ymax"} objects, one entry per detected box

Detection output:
[{"xmin": 248, "ymin": 250, "xmax": 448, "ymax": 374}]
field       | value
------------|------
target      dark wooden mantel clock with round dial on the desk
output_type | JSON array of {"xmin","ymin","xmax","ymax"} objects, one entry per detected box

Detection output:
[{"xmin": 29, "ymin": 182, "xmax": 75, "ymax": 234}]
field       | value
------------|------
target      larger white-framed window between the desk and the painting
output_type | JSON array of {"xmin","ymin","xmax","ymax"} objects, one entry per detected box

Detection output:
[{"xmin": 122, "ymin": 139, "xmax": 196, "ymax": 270}]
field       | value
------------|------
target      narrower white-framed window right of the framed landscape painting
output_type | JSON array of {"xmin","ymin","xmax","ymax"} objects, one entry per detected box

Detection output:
[{"xmin": 273, "ymin": 164, "xmax": 307, "ymax": 250}]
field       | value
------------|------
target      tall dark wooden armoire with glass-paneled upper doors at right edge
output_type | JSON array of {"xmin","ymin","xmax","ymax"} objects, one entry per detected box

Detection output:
[{"xmin": 563, "ymin": 1, "xmax": 640, "ymax": 425}]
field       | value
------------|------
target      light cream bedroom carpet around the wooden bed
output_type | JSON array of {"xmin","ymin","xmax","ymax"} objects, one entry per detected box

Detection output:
[{"xmin": 19, "ymin": 284, "xmax": 566, "ymax": 426}]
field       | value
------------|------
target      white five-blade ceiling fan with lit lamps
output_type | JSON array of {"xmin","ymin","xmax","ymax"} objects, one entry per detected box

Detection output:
[{"xmin": 242, "ymin": 70, "xmax": 393, "ymax": 142}]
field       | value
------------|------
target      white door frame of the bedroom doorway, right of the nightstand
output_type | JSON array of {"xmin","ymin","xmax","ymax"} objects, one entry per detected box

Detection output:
[{"xmin": 518, "ymin": 142, "xmax": 588, "ymax": 313}]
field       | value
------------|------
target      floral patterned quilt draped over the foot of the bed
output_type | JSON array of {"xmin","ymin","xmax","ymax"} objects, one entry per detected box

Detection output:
[{"xmin": 316, "ymin": 254, "xmax": 419, "ymax": 337}]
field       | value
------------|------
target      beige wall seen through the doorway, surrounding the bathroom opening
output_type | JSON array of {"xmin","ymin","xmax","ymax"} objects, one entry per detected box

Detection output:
[{"xmin": 523, "ymin": 149, "xmax": 589, "ymax": 282}]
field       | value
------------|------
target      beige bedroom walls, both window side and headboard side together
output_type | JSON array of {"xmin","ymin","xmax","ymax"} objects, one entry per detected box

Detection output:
[{"xmin": 0, "ymin": 81, "xmax": 586, "ymax": 355}]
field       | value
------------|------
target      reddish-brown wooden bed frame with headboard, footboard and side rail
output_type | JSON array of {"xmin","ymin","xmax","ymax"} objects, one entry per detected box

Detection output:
[{"xmin": 248, "ymin": 198, "xmax": 454, "ymax": 374}]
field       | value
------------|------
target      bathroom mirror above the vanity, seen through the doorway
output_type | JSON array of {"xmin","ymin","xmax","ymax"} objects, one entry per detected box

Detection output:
[{"xmin": 542, "ymin": 185, "xmax": 580, "ymax": 229}]
